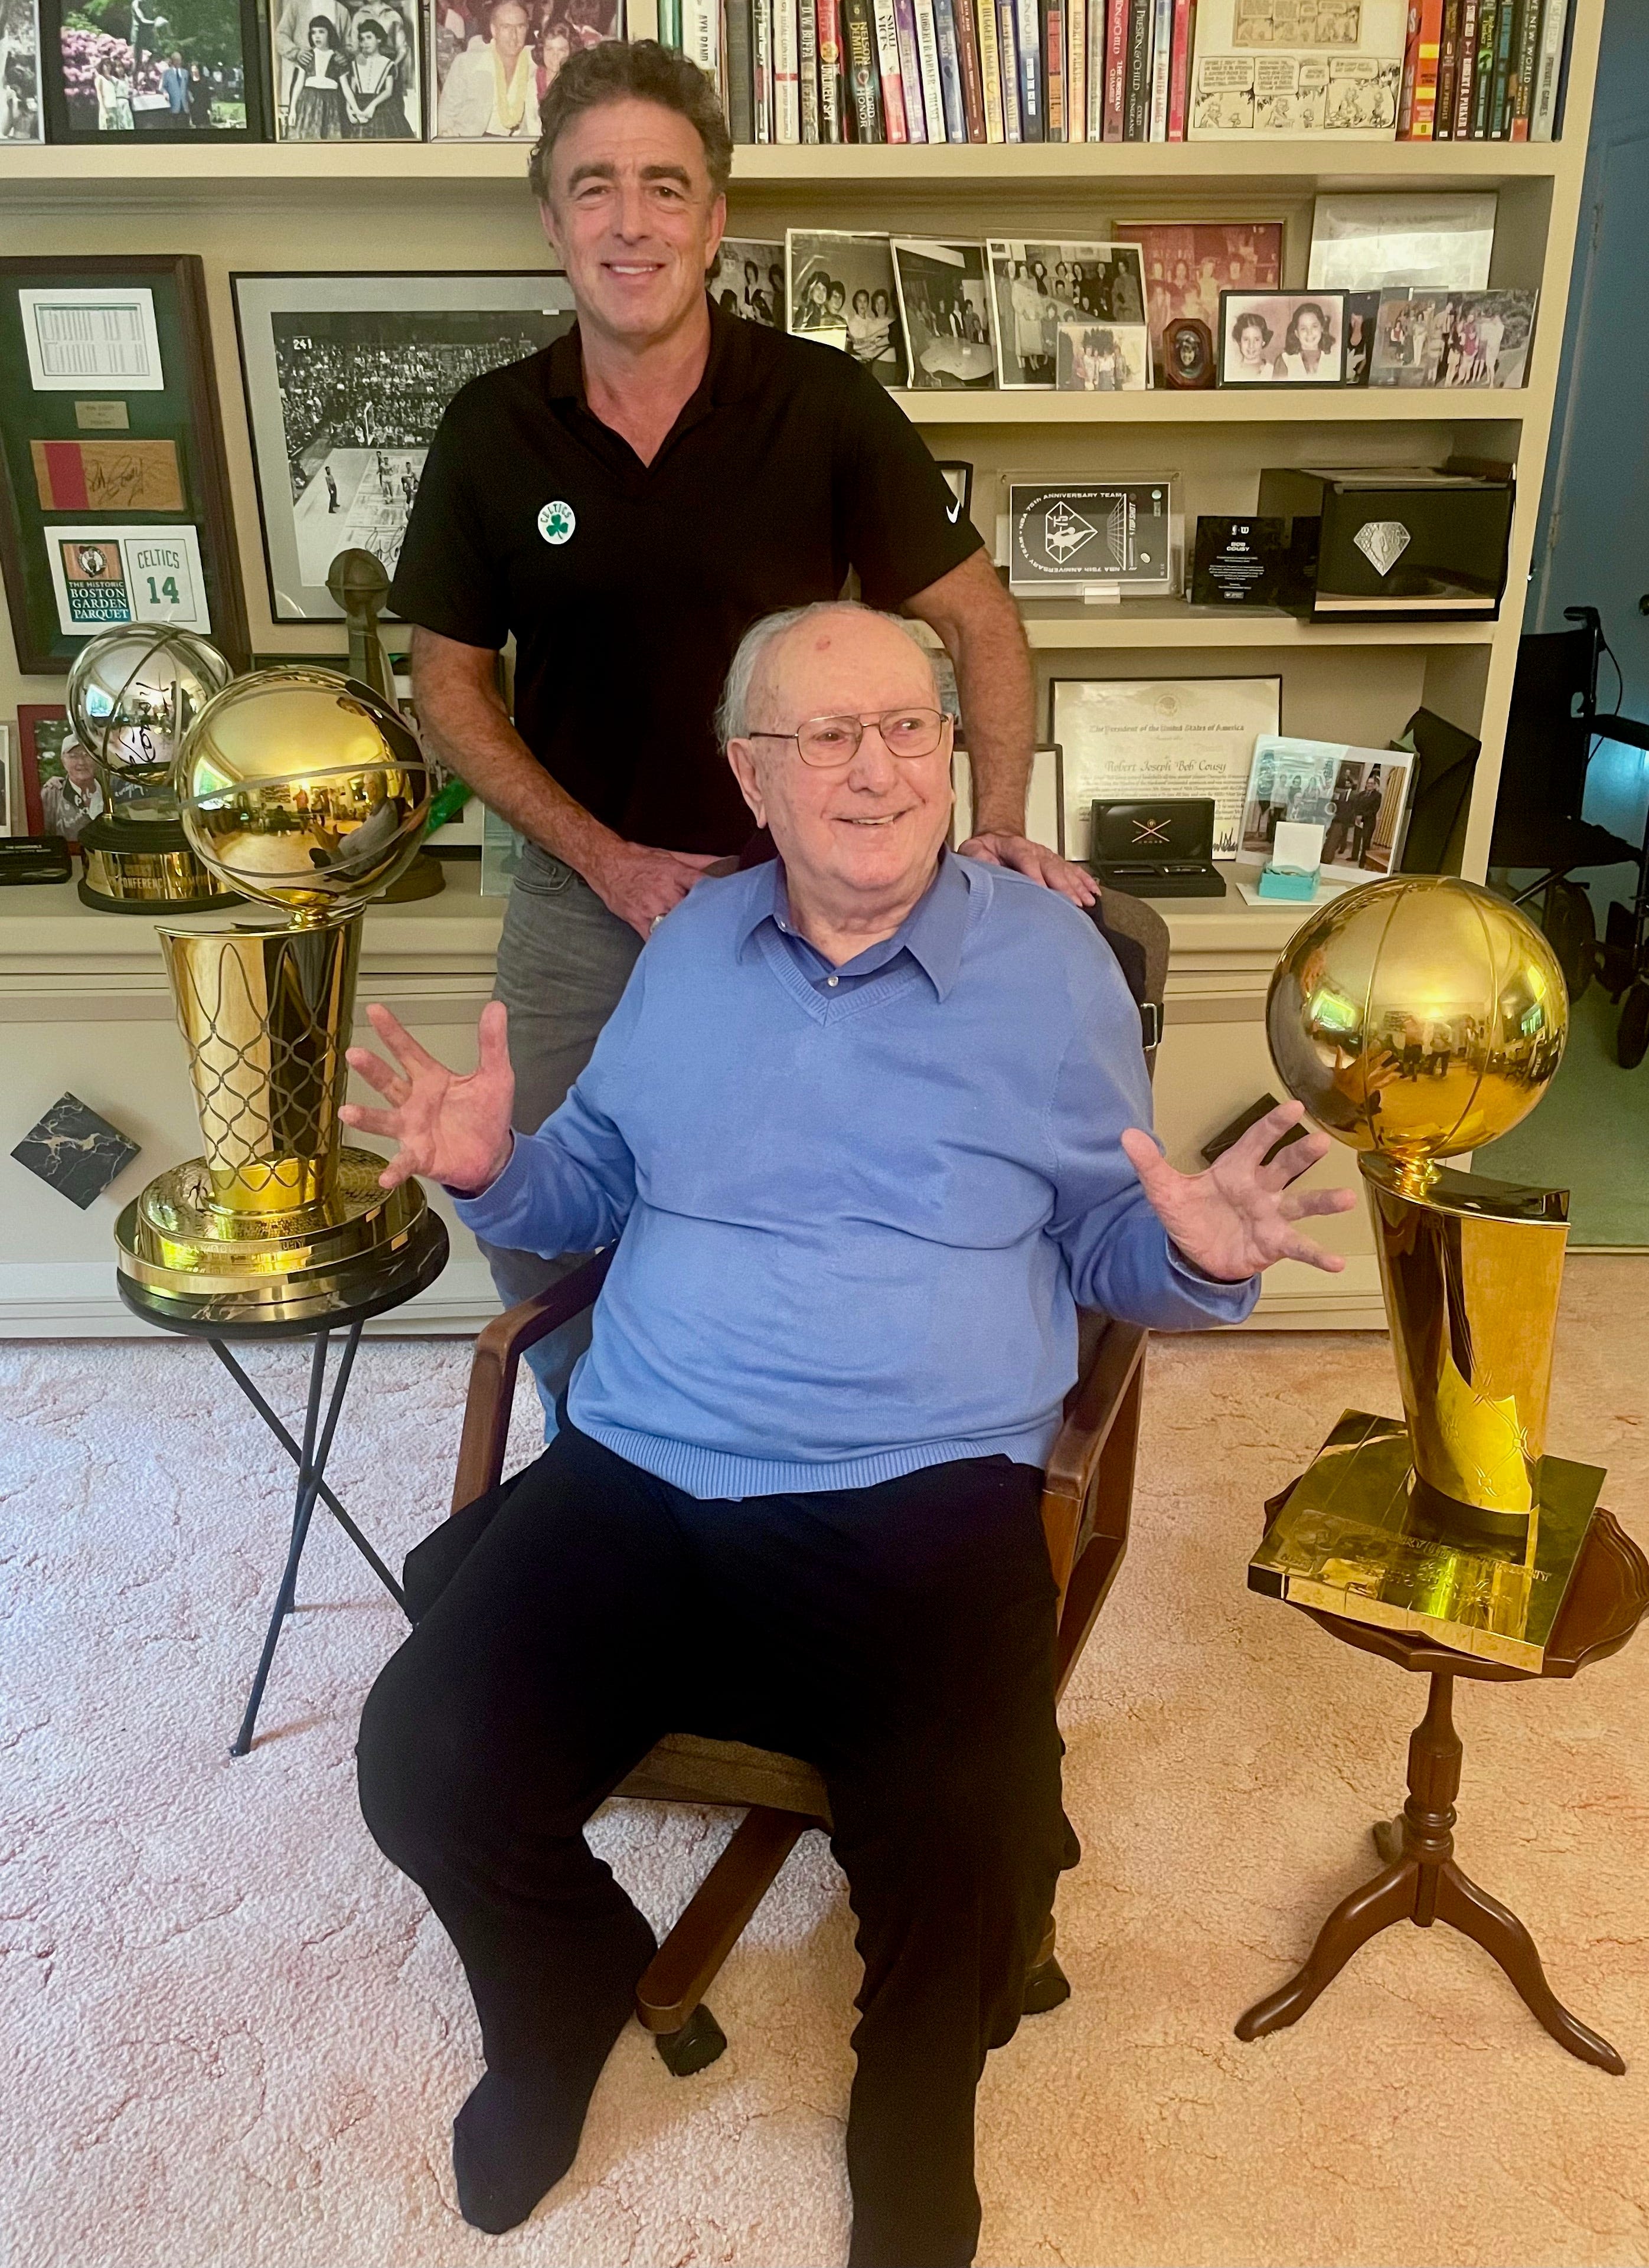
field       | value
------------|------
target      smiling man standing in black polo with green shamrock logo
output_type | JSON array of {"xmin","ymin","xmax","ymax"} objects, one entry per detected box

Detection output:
[{"xmin": 390, "ymin": 40, "xmax": 1093, "ymax": 1384}]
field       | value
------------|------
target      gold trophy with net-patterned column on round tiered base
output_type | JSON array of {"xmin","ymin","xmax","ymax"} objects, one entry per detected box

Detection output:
[{"xmin": 116, "ymin": 667, "xmax": 447, "ymax": 1334}]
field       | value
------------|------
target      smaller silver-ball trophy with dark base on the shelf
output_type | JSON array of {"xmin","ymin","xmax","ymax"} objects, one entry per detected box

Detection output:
[{"xmin": 64, "ymin": 622, "xmax": 234, "ymax": 914}]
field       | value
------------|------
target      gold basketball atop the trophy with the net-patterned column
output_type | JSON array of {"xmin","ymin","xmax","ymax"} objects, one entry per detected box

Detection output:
[{"xmin": 177, "ymin": 667, "xmax": 429, "ymax": 926}]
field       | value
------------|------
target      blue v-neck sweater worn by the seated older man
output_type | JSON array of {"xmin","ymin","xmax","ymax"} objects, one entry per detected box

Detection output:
[{"xmin": 458, "ymin": 855, "xmax": 1259, "ymax": 1497}]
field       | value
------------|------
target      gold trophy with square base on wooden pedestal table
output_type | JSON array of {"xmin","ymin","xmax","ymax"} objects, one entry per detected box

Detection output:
[{"xmin": 1248, "ymin": 875, "xmax": 1604, "ymax": 1672}]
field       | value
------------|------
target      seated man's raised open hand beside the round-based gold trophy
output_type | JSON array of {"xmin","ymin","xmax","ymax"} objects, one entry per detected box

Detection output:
[{"xmin": 338, "ymin": 1000, "xmax": 515, "ymax": 1195}]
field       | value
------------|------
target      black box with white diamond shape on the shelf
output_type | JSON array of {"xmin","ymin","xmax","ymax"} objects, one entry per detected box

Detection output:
[{"xmin": 1259, "ymin": 465, "xmax": 1513, "ymax": 622}]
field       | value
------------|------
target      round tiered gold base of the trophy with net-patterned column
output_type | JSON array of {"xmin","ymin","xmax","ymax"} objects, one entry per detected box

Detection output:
[{"xmin": 116, "ymin": 1150, "xmax": 447, "ymax": 1336}]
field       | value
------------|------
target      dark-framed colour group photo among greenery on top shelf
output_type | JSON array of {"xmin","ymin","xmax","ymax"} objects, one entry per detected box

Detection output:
[{"xmin": 41, "ymin": 0, "xmax": 267, "ymax": 143}]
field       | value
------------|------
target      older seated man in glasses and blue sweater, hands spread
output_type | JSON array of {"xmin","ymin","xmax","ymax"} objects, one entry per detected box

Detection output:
[{"xmin": 345, "ymin": 606, "xmax": 1352, "ymax": 2268}]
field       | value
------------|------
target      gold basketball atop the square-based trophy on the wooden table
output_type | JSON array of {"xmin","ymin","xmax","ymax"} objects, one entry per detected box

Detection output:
[{"xmin": 1266, "ymin": 875, "xmax": 1570, "ymax": 1186}]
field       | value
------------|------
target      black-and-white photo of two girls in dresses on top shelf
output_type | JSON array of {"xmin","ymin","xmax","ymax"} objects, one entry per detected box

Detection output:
[{"xmin": 270, "ymin": 0, "xmax": 424, "ymax": 140}]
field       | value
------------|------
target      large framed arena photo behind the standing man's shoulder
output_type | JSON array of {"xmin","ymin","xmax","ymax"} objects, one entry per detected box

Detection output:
[{"xmin": 229, "ymin": 272, "xmax": 574, "ymax": 622}]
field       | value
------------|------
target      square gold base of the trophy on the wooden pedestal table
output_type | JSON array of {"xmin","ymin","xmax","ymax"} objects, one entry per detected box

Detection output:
[{"xmin": 1248, "ymin": 1411, "xmax": 1604, "ymax": 1676}]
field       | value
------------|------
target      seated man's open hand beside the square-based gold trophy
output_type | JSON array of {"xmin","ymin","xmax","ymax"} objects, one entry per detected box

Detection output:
[{"xmin": 1123, "ymin": 1102, "xmax": 1356, "ymax": 1284}]
